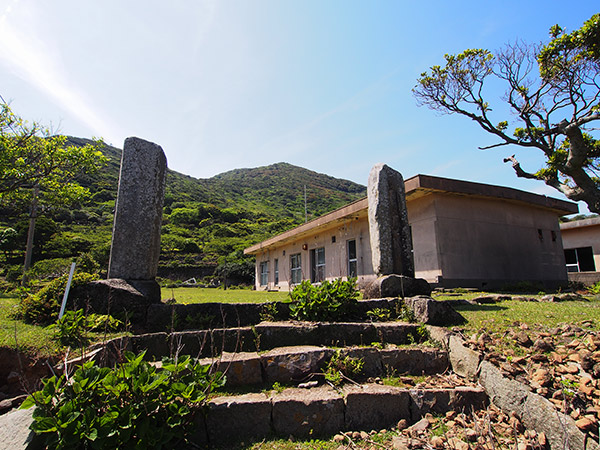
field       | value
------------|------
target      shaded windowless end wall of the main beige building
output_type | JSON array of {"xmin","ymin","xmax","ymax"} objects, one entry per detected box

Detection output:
[{"xmin": 431, "ymin": 194, "xmax": 567, "ymax": 288}]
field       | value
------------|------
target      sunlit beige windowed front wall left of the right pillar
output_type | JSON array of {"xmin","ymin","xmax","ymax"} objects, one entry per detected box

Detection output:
[{"xmin": 256, "ymin": 218, "xmax": 375, "ymax": 291}]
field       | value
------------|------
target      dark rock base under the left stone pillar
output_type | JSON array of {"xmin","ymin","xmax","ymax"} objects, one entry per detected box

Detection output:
[{"xmin": 69, "ymin": 278, "xmax": 160, "ymax": 325}]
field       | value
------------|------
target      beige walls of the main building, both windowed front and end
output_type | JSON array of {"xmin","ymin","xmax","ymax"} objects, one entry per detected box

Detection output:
[{"xmin": 256, "ymin": 192, "xmax": 568, "ymax": 290}]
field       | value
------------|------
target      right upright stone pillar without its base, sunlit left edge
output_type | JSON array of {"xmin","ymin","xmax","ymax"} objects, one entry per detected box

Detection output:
[{"xmin": 367, "ymin": 163, "xmax": 415, "ymax": 278}]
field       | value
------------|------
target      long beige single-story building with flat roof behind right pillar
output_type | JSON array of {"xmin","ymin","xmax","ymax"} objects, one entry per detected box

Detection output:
[{"xmin": 244, "ymin": 175, "xmax": 578, "ymax": 290}]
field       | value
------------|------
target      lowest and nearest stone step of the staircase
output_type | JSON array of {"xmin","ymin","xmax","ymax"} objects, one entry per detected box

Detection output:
[{"xmin": 193, "ymin": 384, "xmax": 489, "ymax": 445}]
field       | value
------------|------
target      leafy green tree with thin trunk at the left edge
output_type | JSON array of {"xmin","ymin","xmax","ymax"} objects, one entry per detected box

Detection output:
[{"xmin": 0, "ymin": 103, "xmax": 106, "ymax": 282}]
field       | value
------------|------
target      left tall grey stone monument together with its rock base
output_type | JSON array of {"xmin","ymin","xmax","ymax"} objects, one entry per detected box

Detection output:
[{"xmin": 72, "ymin": 137, "xmax": 167, "ymax": 328}]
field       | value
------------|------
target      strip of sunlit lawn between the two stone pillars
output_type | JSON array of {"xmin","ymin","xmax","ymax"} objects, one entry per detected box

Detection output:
[{"xmin": 161, "ymin": 287, "xmax": 289, "ymax": 304}]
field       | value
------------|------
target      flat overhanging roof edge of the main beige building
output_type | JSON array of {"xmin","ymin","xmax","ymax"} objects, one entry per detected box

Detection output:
[{"xmin": 244, "ymin": 174, "xmax": 579, "ymax": 255}]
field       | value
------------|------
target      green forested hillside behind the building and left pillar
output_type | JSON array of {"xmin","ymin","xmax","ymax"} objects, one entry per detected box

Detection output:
[{"xmin": 0, "ymin": 137, "xmax": 366, "ymax": 283}]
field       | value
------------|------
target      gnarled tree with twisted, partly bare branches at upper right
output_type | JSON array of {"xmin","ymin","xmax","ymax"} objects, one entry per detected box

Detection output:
[{"xmin": 413, "ymin": 14, "xmax": 600, "ymax": 213}]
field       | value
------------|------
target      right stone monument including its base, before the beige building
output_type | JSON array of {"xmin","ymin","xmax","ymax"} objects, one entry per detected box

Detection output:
[{"xmin": 365, "ymin": 164, "xmax": 431, "ymax": 298}]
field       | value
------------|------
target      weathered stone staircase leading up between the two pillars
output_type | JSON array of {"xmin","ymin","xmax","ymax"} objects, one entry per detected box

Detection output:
[{"xmin": 96, "ymin": 321, "xmax": 488, "ymax": 445}]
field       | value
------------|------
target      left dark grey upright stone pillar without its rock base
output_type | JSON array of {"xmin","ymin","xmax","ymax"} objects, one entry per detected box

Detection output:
[{"xmin": 108, "ymin": 137, "xmax": 167, "ymax": 282}]
